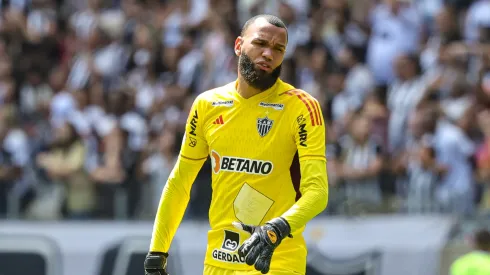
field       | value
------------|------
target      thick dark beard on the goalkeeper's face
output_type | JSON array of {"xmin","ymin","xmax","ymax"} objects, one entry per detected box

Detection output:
[{"xmin": 238, "ymin": 53, "xmax": 282, "ymax": 92}]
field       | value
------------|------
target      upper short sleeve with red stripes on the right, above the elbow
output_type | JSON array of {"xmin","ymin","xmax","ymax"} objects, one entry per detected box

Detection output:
[{"xmin": 294, "ymin": 91, "xmax": 326, "ymax": 160}]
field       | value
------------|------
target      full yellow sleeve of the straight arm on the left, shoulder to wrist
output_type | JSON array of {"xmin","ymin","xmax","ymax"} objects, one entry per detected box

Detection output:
[{"xmin": 150, "ymin": 97, "xmax": 208, "ymax": 252}]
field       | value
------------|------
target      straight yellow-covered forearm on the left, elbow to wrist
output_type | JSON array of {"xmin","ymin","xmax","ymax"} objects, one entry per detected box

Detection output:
[{"xmin": 150, "ymin": 157, "xmax": 205, "ymax": 252}]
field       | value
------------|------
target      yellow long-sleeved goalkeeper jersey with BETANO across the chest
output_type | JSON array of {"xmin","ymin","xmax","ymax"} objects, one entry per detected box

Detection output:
[{"xmin": 151, "ymin": 80, "xmax": 328, "ymax": 274}]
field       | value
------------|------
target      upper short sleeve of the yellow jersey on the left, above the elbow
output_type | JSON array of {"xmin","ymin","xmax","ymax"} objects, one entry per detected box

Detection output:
[{"xmin": 180, "ymin": 96, "xmax": 208, "ymax": 160}]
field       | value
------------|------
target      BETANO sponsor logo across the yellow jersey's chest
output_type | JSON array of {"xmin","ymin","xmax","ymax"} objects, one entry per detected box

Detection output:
[{"xmin": 211, "ymin": 150, "xmax": 274, "ymax": 176}]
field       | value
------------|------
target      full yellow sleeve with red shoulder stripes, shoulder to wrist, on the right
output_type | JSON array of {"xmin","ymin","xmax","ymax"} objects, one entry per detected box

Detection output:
[{"xmin": 282, "ymin": 92, "xmax": 328, "ymax": 232}]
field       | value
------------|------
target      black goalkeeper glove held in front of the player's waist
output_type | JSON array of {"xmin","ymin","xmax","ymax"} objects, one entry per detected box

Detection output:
[{"xmin": 233, "ymin": 217, "xmax": 293, "ymax": 274}]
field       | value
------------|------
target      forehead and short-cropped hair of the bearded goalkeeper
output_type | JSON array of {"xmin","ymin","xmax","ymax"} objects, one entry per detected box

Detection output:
[{"xmin": 245, "ymin": 18, "xmax": 287, "ymax": 44}]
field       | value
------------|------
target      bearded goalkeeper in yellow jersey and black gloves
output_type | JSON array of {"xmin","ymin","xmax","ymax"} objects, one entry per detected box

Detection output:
[{"xmin": 145, "ymin": 15, "xmax": 328, "ymax": 275}]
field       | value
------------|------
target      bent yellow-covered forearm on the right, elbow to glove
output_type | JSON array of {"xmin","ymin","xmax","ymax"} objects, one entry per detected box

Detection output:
[{"xmin": 282, "ymin": 160, "xmax": 328, "ymax": 232}]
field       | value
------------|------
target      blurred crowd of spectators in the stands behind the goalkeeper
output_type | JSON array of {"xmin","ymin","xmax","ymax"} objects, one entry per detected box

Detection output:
[{"xmin": 0, "ymin": 0, "xmax": 490, "ymax": 220}]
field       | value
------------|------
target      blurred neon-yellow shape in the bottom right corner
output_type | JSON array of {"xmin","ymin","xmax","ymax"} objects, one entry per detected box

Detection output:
[{"xmin": 451, "ymin": 251, "xmax": 490, "ymax": 275}]
